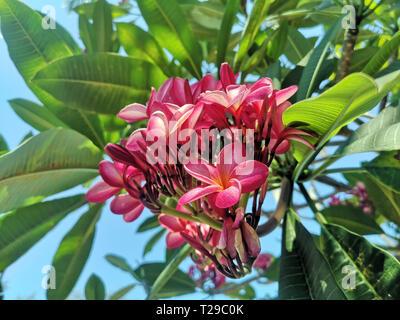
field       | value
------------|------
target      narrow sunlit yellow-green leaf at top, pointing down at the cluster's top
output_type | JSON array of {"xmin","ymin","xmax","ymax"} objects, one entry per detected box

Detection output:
[{"xmin": 233, "ymin": 0, "xmax": 272, "ymax": 72}]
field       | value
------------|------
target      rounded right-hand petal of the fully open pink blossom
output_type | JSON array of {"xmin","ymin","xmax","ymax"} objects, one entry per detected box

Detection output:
[{"xmin": 233, "ymin": 160, "xmax": 269, "ymax": 193}]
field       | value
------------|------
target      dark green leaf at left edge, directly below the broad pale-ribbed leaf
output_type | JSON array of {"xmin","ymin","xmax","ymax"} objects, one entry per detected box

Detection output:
[{"xmin": 0, "ymin": 195, "xmax": 86, "ymax": 271}]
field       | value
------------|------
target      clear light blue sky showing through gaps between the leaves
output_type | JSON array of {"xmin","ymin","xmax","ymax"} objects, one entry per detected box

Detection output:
[{"xmin": 0, "ymin": 0, "xmax": 380, "ymax": 299}]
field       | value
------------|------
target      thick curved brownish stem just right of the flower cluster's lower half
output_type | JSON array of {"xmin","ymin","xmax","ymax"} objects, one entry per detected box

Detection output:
[{"xmin": 257, "ymin": 177, "xmax": 293, "ymax": 237}]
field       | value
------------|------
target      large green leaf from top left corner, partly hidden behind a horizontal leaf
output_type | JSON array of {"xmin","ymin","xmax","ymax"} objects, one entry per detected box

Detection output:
[{"xmin": 0, "ymin": 0, "xmax": 104, "ymax": 147}]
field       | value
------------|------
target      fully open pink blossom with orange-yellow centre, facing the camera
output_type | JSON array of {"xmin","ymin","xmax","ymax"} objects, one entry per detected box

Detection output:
[{"xmin": 179, "ymin": 144, "xmax": 268, "ymax": 209}]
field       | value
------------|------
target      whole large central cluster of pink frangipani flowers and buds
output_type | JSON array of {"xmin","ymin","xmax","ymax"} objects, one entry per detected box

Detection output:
[{"xmin": 87, "ymin": 63, "xmax": 313, "ymax": 278}]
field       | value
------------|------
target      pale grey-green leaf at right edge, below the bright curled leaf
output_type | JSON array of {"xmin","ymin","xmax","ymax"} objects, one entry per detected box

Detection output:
[{"xmin": 334, "ymin": 106, "xmax": 400, "ymax": 157}]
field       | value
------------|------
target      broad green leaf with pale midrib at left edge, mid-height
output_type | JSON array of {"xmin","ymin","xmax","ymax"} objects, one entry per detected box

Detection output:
[{"xmin": 0, "ymin": 128, "xmax": 102, "ymax": 212}]
